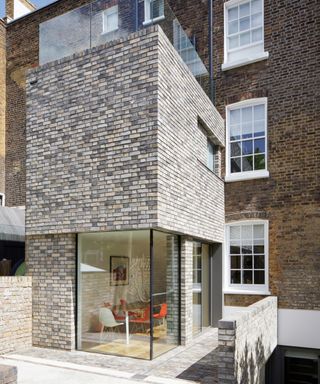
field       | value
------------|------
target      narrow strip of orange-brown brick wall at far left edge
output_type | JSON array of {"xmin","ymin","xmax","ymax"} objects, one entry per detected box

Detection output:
[{"xmin": 0, "ymin": 20, "xmax": 6, "ymax": 193}]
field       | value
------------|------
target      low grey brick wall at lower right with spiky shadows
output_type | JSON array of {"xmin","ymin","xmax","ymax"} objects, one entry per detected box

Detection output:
[{"xmin": 219, "ymin": 297, "xmax": 277, "ymax": 384}]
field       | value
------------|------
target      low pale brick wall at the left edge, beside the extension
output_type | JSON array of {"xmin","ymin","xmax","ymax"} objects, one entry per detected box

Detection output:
[{"xmin": 0, "ymin": 276, "xmax": 32, "ymax": 354}]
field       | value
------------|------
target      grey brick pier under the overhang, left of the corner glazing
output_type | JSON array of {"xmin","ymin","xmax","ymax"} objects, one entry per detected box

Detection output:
[{"xmin": 26, "ymin": 234, "xmax": 76, "ymax": 350}]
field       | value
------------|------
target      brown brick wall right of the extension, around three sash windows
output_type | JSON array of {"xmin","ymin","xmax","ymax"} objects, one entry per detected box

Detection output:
[{"xmin": 214, "ymin": 0, "xmax": 320, "ymax": 310}]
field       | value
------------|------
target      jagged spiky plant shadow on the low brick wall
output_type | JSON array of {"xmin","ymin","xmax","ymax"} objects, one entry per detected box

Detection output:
[{"xmin": 235, "ymin": 336, "xmax": 270, "ymax": 384}]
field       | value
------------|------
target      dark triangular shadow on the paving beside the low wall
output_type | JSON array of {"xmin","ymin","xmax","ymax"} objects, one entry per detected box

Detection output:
[{"xmin": 177, "ymin": 347, "xmax": 219, "ymax": 384}]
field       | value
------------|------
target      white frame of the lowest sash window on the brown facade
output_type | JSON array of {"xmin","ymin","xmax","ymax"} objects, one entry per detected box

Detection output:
[{"xmin": 223, "ymin": 220, "xmax": 271, "ymax": 295}]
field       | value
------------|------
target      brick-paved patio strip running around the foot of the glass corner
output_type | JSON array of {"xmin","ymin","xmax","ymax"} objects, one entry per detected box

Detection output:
[{"xmin": 5, "ymin": 328, "xmax": 218, "ymax": 384}]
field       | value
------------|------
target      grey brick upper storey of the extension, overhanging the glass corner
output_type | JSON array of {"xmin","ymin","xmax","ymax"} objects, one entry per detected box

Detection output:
[{"xmin": 26, "ymin": 27, "xmax": 224, "ymax": 241}]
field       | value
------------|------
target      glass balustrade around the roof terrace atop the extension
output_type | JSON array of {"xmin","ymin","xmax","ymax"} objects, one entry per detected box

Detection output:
[{"xmin": 39, "ymin": 0, "xmax": 210, "ymax": 97}]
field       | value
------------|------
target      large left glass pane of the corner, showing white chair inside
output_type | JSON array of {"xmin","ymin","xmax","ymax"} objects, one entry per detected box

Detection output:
[{"xmin": 78, "ymin": 231, "xmax": 150, "ymax": 359}]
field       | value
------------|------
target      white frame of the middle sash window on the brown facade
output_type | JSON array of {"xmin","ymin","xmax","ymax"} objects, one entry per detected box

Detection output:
[{"xmin": 225, "ymin": 97, "xmax": 269, "ymax": 182}]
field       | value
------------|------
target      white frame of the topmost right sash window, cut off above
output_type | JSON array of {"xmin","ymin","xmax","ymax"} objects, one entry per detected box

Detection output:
[{"xmin": 221, "ymin": 0, "xmax": 269, "ymax": 70}]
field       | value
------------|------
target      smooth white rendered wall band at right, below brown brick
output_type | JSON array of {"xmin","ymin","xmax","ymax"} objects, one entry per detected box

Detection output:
[{"xmin": 278, "ymin": 309, "xmax": 320, "ymax": 349}]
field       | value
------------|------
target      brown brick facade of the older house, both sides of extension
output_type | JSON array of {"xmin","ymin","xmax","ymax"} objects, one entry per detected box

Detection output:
[{"xmin": 0, "ymin": 0, "xmax": 320, "ymax": 378}]
